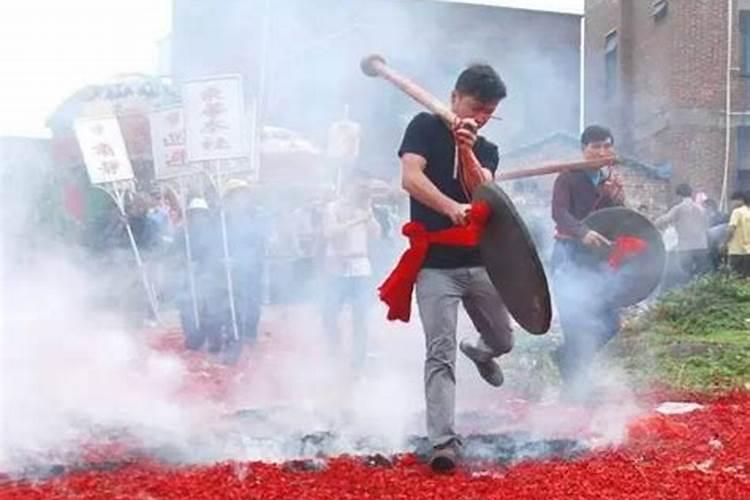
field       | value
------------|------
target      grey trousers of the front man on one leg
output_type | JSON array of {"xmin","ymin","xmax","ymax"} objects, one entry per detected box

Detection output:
[{"xmin": 416, "ymin": 267, "xmax": 513, "ymax": 446}]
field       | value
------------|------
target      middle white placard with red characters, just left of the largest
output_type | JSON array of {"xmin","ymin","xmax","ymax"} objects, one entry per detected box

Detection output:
[{"xmin": 150, "ymin": 107, "xmax": 195, "ymax": 179}]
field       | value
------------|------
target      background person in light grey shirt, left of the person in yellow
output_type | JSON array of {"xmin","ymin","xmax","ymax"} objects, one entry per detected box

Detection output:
[{"xmin": 654, "ymin": 184, "xmax": 709, "ymax": 284}]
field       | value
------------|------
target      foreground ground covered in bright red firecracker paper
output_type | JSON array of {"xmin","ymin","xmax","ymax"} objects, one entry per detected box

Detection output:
[{"xmin": 0, "ymin": 392, "xmax": 750, "ymax": 500}]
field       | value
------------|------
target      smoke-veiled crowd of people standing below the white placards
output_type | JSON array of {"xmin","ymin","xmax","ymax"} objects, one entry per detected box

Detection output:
[{"xmin": 80, "ymin": 168, "xmax": 400, "ymax": 369}]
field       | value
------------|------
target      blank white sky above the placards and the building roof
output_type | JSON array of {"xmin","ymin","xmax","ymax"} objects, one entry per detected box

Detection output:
[{"xmin": 0, "ymin": 0, "xmax": 584, "ymax": 137}]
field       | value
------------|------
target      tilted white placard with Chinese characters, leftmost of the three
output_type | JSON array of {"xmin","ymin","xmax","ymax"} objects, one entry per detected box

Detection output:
[{"xmin": 74, "ymin": 116, "xmax": 133, "ymax": 184}]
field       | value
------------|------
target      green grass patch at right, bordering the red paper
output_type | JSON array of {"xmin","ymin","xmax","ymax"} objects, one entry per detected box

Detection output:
[{"xmin": 613, "ymin": 274, "xmax": 750, "ymax": 390}]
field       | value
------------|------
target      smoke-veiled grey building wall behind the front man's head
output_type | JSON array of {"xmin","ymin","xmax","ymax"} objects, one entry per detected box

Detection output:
[{"xmin": 173, "ymin": 0, "xmax": 580, "ymax": 177}]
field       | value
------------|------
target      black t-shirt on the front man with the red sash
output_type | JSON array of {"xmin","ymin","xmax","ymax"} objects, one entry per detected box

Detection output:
[{"xmin": 398, "ymin": 113, "xmax": 498, "ymax": 269}]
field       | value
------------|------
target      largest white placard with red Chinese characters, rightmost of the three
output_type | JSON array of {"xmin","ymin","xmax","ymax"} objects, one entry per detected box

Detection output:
[{"xmin": 182, "ymin": 75, "xmax": 249, "ymax": 162}]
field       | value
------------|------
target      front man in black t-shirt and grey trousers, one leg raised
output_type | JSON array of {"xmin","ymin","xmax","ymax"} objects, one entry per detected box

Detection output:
[{"xmin": 398, "ymin": 65, "xmax": 513, "ymax": 471}]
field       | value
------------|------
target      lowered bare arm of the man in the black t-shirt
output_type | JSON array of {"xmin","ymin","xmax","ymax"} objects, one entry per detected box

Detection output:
[{"xmin": 401, "ymin": 153, "xmax": 469, "ymax": 225}]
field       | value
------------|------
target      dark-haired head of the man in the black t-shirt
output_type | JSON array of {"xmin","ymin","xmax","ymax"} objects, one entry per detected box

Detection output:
[{"xmin": 451, "ymin": 64, "xmax": 507, "ymax": 128}]
